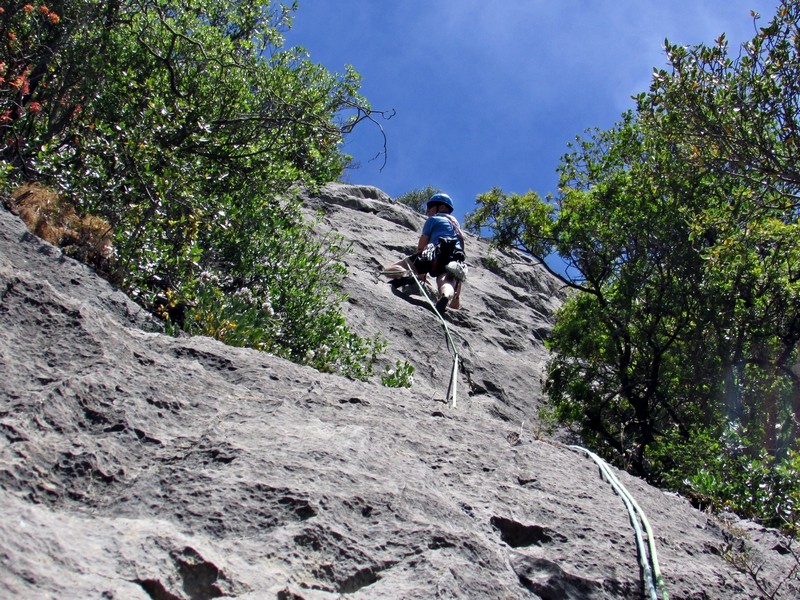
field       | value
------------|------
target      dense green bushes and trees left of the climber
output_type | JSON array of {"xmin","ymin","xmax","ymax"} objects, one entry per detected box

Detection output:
[{"xmin": 0, "ymin": 0, "xmax": 383, "ymax": 378}]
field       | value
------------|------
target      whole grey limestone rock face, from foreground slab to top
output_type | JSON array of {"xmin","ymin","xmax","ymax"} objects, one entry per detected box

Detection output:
[{"xmin": 0, "ymin": 185, "xmax": 798, "ymax": 600}]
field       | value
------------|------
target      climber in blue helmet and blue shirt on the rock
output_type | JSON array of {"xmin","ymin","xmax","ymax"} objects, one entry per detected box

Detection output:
[{"xmin": 383, "ymin": 193, "xmax": 466, "ymax": 314}]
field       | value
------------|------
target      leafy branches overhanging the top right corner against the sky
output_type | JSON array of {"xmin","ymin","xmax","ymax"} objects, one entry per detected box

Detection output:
[{"xmin": 638, "ymin": 0, "xmax": 800, "ymax": 195}]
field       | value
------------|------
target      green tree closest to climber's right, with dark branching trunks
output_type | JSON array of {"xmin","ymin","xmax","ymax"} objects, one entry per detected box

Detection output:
[{"xmin": 467, "ymin": 114, "xmax": 714, "ymax": 475}]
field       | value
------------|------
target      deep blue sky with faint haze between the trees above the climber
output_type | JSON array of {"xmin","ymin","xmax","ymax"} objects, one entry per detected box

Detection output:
[{"xmin": 286, "ymin": 0, "xmax": 778, "ymax": 224}]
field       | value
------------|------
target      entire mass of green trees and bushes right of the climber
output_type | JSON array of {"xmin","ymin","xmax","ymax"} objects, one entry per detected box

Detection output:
[{"xmin": 467, "ymin": 0, "xmax": 800, "ymax": 524}]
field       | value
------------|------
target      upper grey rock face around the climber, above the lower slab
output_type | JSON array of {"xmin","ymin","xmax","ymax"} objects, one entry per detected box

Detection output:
[{"xmin": 296, "ymin": 184, "xmax": 564, "ymax": 428}]
